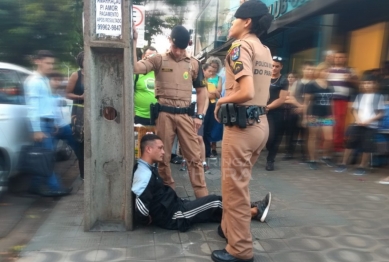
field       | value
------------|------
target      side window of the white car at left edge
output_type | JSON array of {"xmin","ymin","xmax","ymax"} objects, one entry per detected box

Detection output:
[{"xmin": 0, "ymin": 69, "xmax": 24, "ymax": 104}]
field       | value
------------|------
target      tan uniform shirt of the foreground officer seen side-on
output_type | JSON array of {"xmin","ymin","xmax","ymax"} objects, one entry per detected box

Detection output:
[{"xmin": 225, "ymin": 35, "xmax": 273, "ymax": 106}]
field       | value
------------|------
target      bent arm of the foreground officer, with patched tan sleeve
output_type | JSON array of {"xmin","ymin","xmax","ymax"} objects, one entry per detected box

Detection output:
[{"xmin": 218, "ymin": 42, "xmax": 255, "ymax": 105}]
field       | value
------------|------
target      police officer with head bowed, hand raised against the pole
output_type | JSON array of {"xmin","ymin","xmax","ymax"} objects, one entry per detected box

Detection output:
[{"xmin": 134, "ymin": 25, "xmax": 208, "ymax": 198}]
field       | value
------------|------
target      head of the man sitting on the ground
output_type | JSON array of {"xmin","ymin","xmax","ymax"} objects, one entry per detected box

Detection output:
[{"xmin": 140, "ymin": 134, "xmax": 165, "ymax": 163}]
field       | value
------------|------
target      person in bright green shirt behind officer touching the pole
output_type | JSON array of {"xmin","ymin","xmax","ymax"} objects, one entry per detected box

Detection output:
[{"xmin": 134, "ymin": 46, "xmax": 158, "ymax": 126}]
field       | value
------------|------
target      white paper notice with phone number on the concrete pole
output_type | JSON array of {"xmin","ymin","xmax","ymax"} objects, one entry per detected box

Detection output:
[{"xmin": 96, "ymin": 0, "xmax": 122, "ymax": 36}]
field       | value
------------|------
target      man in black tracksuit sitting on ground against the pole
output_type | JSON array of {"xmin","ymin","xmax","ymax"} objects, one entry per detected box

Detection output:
[{"xmin": 131, "ymin": 134, "xmax": 271, "ymax": 232}]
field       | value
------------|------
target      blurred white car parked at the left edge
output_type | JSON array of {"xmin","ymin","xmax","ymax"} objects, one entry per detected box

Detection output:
[{"xmin": 0, "ymin": 62, "xmax": 73, "ymax": 192}]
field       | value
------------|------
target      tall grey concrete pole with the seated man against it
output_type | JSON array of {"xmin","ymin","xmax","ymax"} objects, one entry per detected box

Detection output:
[{"xmin": 84, "ymin": 0, "xmax": 134, "ymax": 231}]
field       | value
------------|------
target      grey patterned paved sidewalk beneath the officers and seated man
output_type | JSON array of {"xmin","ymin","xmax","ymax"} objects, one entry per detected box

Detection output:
[{"xmin": 18, "ymin": 155, "xmax": 389, "ymax": 262}]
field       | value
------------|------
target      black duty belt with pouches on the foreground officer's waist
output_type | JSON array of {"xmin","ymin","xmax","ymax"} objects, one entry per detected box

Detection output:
[{"xmin": 218, "ymin": 103, "xmax": 266, "ymax": 128}]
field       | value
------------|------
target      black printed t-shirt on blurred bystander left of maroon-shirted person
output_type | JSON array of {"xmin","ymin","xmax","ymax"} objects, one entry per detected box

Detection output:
[{"xmin": 305, "ymin": 81, "xmax": 334, "ymax": 117}]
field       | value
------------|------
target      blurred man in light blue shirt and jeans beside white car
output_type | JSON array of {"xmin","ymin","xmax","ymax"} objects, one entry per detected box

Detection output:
[{"xmin": 24, "ymin": 50, "xmax": 72, "ymax": 197}]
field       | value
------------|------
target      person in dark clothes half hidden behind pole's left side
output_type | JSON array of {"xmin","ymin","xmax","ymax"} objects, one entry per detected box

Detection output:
[{"xmin": 66, "ymin": 52, "xmax": 84, "ymax": 180}]
